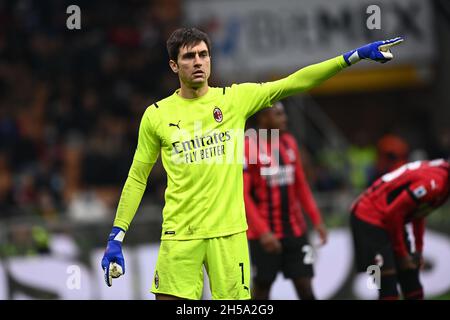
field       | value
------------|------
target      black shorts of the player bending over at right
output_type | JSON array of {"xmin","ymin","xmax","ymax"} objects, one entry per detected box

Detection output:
[{"xmin": 350, "ymin": 213, "xmax": 410, "ymax": 272}]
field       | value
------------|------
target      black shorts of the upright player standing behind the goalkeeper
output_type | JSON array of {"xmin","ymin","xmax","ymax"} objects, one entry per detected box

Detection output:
[{"xmin": 249, "ymin": 235, "xmax": 314, "ymax": 284}]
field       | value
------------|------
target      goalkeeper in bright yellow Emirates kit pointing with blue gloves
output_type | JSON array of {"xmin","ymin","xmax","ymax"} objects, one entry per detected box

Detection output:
[{"xmin": 101, "ymin": 28, "xmax": 403, "ymax": 299}]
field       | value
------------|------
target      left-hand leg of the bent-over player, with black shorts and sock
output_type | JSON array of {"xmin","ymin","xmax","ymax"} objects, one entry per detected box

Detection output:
[{"xmin": 350, "ymin": 214, "xmax": 399, "ymax": 300}]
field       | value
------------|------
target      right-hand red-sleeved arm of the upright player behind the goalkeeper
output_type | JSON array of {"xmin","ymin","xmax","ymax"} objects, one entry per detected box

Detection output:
[{"xmin": 295, "ymin": 150, "xmax": 328, "ymax": 244}]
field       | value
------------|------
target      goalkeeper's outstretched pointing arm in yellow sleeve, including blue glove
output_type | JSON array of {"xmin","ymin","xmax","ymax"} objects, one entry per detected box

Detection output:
[{"xmin": 238, "ymin": 37, "xmax": 403, "ymax": 117}]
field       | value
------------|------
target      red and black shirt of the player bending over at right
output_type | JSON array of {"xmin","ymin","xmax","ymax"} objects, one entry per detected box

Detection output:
[{"xmin": 352, "ymin": 159, "xmax": 450, "ymax": 256}]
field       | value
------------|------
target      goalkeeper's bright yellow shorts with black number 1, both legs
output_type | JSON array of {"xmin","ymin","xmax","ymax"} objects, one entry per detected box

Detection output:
[{"xmin": 151, "ymin": 232, "xmax": 251, "ymax": 300}]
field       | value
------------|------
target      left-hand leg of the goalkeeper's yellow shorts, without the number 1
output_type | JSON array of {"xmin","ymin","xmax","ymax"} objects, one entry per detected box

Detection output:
[{"xmin": 151, "ymin": 240, "xmax": 206, "ymax": 300}]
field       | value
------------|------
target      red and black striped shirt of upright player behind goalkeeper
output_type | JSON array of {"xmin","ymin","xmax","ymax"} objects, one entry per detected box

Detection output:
[{"xmin": 244, "ymin": 133, "xmax": 322, "ymax": 239}]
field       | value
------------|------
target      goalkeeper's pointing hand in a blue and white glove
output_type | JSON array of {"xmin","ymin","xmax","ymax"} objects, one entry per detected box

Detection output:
[{"xmin": 343, "ymin": 37, "xmax": 404, "ymax": 66}]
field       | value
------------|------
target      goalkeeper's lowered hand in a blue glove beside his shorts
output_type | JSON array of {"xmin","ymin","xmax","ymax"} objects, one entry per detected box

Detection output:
[{"xmin": 102, "ymin": 227, "xmax": 125, "ymax": 287}]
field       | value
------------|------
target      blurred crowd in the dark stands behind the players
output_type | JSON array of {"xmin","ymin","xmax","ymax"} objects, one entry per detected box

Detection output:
[{"xmin": 0, "ymin": 0, "xmax": 450, "ymax": 222}]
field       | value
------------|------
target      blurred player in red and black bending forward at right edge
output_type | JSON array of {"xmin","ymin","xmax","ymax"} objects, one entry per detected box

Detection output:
[{"xmin": 350, "ymin": 159, "xmax": 450, "ymax": 300}]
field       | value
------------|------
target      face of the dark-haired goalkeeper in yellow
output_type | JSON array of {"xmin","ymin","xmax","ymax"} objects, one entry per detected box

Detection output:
[{"xmin": 169, "ymin": 41, "xmax": 211, "ymax": 88}]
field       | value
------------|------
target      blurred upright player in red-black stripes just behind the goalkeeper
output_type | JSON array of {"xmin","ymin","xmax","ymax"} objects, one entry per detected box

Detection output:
[{"xmin": 244, "ymin": 102, "xmax": 327, "ymax": 300}]
